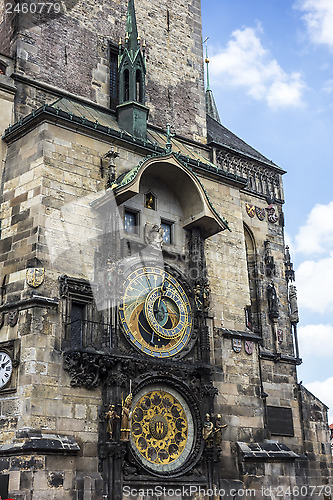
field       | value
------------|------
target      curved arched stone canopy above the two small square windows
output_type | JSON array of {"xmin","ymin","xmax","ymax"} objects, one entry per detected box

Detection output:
[{"xmin": 93, "ymin": 154, "xmax": 228, "ymax": 238}]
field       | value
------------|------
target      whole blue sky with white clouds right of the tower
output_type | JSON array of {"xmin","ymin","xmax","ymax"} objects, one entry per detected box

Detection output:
[{"xmin": 202, "ymin": 0, "xmax": 333, "ymax": 423}]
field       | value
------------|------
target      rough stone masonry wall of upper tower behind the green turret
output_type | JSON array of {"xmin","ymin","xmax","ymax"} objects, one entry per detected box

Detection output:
[{"xmin": 6, "ymin": 0, "xmax": 206, "ymax": 141}]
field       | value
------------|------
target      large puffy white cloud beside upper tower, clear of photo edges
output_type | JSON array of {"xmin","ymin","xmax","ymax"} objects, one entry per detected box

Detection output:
[{"xmin": 210, "ymin": 27, "xmax": 305, "ymax": 109}]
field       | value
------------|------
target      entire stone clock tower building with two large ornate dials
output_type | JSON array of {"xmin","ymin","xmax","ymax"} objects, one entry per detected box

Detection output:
[{"xmin": 0, "ymin": 0, "xmax": 332, "ymax": 500}]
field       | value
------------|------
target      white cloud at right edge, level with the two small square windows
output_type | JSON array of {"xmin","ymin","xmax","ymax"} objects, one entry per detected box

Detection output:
[{"xmin": 295, "ymin": 201, "xmax": 333, "ymax": 255}]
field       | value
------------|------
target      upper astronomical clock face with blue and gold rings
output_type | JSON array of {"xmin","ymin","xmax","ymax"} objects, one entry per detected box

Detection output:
[{"xmin": 119, "ymin": 266, "xmax": 192, "ymax": 358}]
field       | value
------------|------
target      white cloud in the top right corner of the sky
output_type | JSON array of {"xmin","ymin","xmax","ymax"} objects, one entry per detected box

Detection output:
[{"xmin": 295, "ymin": 0, "xmax": 333, "ymax": 50}]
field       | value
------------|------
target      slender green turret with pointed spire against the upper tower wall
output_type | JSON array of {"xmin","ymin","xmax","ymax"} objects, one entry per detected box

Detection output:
[{"xmin": 117, "ymin": 0, "xmax": 148, "ymax": 140}]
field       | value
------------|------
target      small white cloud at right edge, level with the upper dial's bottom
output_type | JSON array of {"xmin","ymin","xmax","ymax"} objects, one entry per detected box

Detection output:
[{"xmin": 298, "ymin": 325, "xmax": 333, "ymax": 356}]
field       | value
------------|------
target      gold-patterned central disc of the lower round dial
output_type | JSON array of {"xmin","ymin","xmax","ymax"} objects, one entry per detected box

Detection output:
[{"xmin": 131, "ymin": 390, "xmax": 188, "ymax": 465}]
